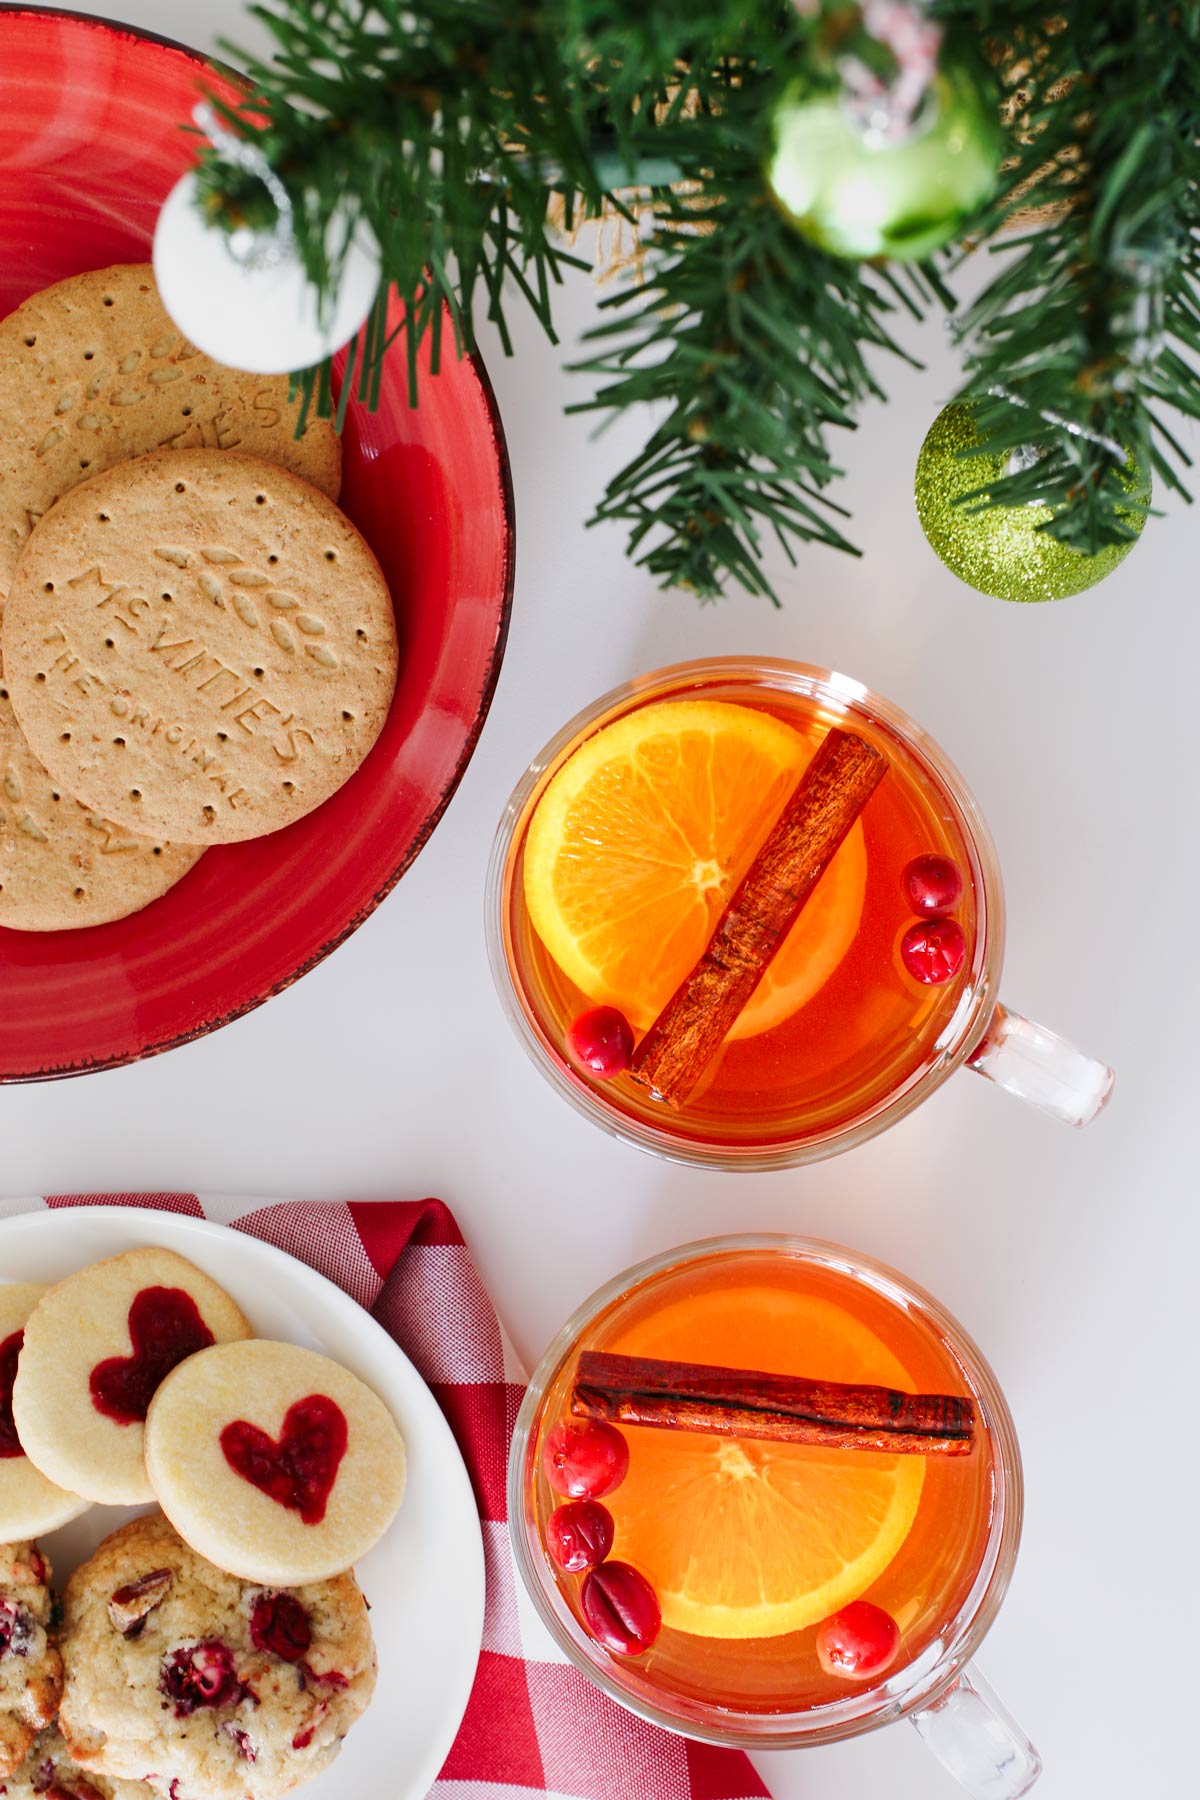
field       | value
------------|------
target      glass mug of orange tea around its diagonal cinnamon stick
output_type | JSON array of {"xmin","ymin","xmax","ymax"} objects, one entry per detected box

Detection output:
[{"xmin": 488, "ymin": 657, "xmax": 1112, "ymax": 1170}]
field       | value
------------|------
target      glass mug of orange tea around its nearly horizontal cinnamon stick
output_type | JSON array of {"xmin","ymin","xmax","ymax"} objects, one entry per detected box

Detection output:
[{"xmin": 507, "ymin": 1237, "xmax": 1042, "ymax": 1800}]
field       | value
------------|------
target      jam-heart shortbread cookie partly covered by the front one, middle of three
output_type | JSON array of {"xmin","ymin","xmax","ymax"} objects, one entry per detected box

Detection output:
[{"xmin": 13, "ymin": 1249, "xmax": 250, "ymax": 1507}]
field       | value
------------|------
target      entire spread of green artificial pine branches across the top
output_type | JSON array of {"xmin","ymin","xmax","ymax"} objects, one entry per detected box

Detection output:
[{"xmin": 201, "ymin": 0, "xmax": 1200, "ymax": 598}]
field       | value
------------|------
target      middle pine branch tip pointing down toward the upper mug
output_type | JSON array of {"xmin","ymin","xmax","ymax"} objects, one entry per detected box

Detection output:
[{"xmin": 572, "ymin": 119, "xmax": 928, "ymax": 598}]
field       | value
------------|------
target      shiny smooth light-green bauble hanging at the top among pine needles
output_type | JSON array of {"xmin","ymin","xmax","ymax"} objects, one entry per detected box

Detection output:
[{"xmin": 765, "ymin": 68, "xmax": 1000, "ymax": 263}]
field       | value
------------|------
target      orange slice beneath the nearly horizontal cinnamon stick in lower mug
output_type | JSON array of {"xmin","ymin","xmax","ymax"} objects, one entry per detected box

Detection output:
[{"xmin": 604, "ymin": 1287, "xmax": 925, "ymax": 1638}]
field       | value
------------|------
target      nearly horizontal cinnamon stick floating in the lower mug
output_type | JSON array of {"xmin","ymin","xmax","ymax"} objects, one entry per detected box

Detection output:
[{"xmin": 570, "ymin": 1350, "xmax": 975, "ymax": 1456}]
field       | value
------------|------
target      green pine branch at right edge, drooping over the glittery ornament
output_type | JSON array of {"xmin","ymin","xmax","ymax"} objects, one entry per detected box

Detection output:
[{"xmin": 954, "ymin": 4, "xmax": 1200, "ymax": 554}]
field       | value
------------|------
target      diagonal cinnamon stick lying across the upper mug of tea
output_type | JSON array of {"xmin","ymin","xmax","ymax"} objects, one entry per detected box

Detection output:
[{"xmin": 630, "ymin": 729, "xmax": 887, "ymax": 1107}]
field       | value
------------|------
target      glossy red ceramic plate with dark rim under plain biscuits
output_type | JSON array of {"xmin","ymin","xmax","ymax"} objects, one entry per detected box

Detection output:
[{"xmin": 0, "ymin": 9, "xmax": 513, "ymax": 1080}]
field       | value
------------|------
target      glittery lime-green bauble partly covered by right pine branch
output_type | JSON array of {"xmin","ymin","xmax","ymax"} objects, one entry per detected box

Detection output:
[{"xmin": 916, "ymin": 405, "xmax": 1150, "ymax": 601}]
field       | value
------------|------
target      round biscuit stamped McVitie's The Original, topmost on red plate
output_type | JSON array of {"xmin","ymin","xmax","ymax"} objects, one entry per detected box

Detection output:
[{"xmin": 4, "ymin": 450, "xmax": 398, "ymax": 844}]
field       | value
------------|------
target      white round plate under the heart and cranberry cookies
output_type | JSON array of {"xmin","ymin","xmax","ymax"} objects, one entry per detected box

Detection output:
[{"xmin": 0, "ymin": 1206, "xmax": 484, "ymax": 1800}]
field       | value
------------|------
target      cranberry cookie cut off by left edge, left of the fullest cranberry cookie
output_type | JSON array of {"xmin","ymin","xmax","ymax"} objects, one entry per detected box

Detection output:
[{"xmin": 0, "ymin": 1544, "xmax": 63, "ymax": 1782}]
